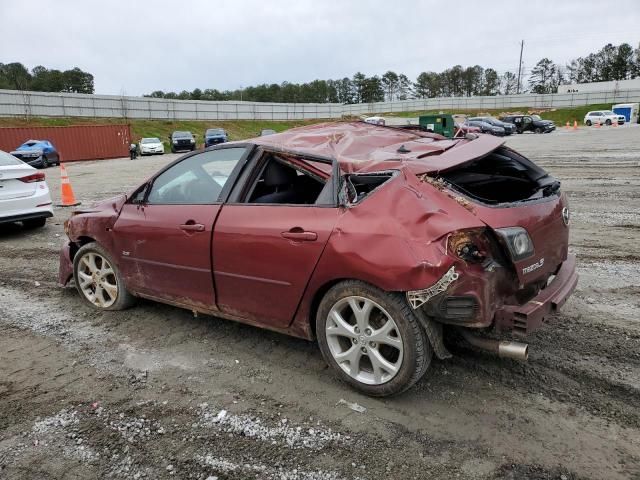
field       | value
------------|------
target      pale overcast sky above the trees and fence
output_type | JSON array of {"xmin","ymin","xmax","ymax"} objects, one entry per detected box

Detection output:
[{"xmin": 0, "ymin": 0, "xmax": 640, "ymax": 95}]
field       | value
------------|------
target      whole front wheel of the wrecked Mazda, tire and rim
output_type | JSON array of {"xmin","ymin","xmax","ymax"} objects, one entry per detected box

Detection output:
[{"xmin": 73, "ymin": 242, "xmax": 136, "ymax": 310}]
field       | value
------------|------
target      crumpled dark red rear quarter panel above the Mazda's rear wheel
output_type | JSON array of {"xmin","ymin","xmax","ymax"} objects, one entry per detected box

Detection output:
[{"xmin": 292, "ymin": 168, "xmax": 484, "ymax": 336}]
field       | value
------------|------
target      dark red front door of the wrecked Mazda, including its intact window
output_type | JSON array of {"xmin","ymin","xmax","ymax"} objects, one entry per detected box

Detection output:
[{"xmin": 114, "ymin": 147, "xmax": 246, "ymax": 309}]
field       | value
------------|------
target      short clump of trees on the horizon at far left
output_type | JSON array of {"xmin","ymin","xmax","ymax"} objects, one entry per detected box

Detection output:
[{"xmin": 0, "ymin": 62, "xmax": 94, "ymax": 93}]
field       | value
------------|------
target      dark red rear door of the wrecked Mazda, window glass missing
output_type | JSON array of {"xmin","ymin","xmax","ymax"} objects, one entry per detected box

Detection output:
[{"xmin": 213, "ymin": 155, "xmax": 339, "ymax": 328}]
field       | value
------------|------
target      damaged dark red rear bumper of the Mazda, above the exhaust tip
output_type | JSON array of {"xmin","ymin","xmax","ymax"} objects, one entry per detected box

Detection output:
[{"xmin": 494, "ymin": 255, "xmax": 578, "ymax": 336}]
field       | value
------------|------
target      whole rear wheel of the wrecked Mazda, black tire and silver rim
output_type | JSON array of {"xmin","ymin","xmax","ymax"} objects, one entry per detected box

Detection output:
[{"xmin": 316, "ymin": 280, "xmax": 433, "ymax": 397}]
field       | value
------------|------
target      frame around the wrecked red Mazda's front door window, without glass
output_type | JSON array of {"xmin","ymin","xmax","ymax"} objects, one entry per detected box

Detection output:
[{"xmin": 127, "ymin": 143, "xmax": 256, "ymax": 205}]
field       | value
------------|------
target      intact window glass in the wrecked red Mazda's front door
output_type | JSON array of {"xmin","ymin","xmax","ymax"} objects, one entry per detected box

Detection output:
[{"xmin": 147, "ymin": 147, "xmax": 246, "ymax": 205}]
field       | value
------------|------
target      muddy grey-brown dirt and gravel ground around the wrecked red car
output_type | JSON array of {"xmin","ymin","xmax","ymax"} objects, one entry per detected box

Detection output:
[{"xmin": 0, "ymin": 127, "xmax": 640, "ymax": 480}]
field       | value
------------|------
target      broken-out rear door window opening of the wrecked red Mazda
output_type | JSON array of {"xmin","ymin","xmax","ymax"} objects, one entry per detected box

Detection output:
[{"xmin": 245, "ymin": 153, "xmax": 335, "ymax": 205}]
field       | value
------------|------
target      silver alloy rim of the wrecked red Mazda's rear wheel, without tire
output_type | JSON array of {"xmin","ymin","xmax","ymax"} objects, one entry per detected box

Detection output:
[{"xmin": 325, "ymin": 296, "xmax": 404, "ymax": 385}]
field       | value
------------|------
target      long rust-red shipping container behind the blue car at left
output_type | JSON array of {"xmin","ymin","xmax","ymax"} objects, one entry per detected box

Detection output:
[{"xmin": 0, "ymin": 125, "xmax": 131, "ymax": 162}]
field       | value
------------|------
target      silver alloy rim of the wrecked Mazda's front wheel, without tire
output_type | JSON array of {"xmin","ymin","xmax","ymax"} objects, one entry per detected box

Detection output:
[{"xmin": 77, "ymin": 252, "xmax": 118, "ymax": 308}]
